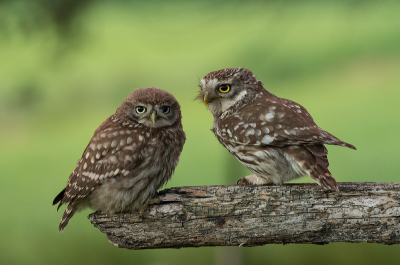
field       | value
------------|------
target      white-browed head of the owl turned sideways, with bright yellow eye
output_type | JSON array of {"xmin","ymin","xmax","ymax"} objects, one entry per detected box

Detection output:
[{"xmin": 197, "ymin": 67, "xmax": 262, "ymax": 117}]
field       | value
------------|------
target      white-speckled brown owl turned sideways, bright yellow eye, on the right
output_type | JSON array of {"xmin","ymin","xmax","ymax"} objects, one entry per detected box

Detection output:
[{"xmin": 197, "ymin": 68, "xmax": 356, "ymax": 191}]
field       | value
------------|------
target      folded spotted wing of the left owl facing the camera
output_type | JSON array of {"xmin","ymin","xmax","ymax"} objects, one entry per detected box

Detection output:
[{"xmin": 53, "ymin": 118, "xmax": 150, "ymax": 231}]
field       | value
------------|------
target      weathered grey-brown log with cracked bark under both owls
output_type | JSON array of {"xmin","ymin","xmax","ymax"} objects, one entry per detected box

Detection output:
[{"xmin": 88, "ymin": 183, "xmax": 400, "ymax": 249}]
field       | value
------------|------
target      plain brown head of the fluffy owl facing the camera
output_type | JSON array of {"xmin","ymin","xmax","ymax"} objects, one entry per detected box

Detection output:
[{"xmin": 117, "ymin": 87, "xmax": 181, "ymax": 128}]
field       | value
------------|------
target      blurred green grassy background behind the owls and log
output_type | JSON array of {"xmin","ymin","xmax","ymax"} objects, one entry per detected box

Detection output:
[{"xmin": 0, "ymin": 0, "xmax": 400, "ymax": 265}]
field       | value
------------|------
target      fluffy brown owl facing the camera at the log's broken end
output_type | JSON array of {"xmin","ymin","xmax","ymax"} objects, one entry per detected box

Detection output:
[{"xmin": 53, "ymin": 87, "xmax": 186, "ymax": 231}]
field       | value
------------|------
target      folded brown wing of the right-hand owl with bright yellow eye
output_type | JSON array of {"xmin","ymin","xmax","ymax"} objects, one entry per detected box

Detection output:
[{"xmin": 213, "ymin": 97, "xmax": 355, "ymax": 149}]
